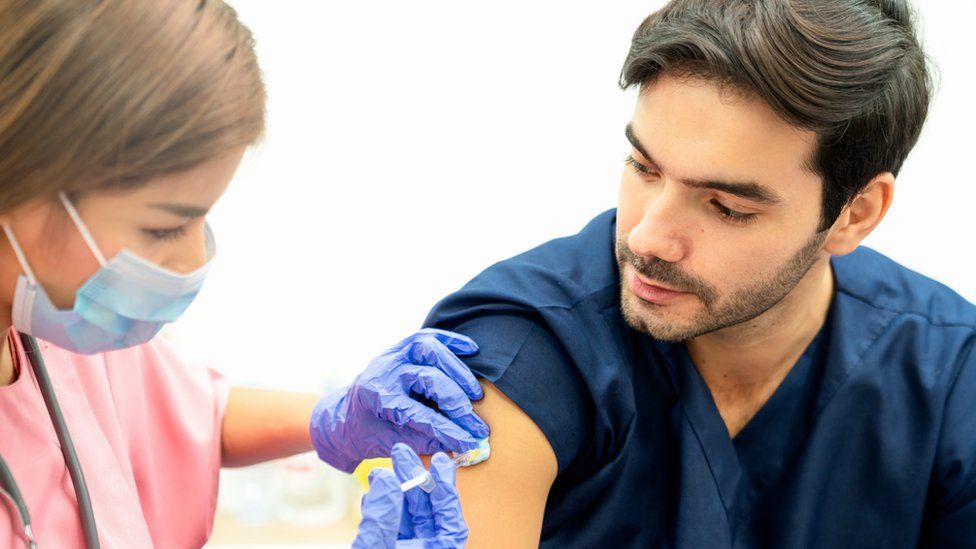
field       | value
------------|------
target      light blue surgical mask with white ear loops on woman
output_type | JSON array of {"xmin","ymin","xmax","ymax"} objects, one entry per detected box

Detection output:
[{"xmin": 3, "ymin": 193, "xmax": 215, "ymax": 354}]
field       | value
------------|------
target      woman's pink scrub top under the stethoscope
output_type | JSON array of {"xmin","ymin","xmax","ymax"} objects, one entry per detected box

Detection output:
[{"xmin": 0, "ymin": 329, "xmax": 230, "ymax": 549}]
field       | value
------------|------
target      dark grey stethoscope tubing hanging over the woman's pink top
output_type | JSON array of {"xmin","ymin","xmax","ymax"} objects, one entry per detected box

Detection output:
[{"xmin": 0, "ymin": 333, "xmax": 99, "ymax": 549}]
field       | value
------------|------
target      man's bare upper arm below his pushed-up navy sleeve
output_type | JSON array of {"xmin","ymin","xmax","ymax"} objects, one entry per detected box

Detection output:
[{"xmin": 440, "ymin": 380, "xmax": 557, "ymax": 549}]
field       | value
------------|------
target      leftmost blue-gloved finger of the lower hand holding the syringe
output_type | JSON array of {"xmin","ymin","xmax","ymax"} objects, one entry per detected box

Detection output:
[{"xmin": 352, "ymin": 469, "xmax": 403, "ymax": 549}]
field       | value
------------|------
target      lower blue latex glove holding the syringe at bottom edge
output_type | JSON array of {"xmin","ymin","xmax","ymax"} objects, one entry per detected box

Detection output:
[{"xmin": 352, "ymin": 444, "xmax": 468, "ymax": 549}]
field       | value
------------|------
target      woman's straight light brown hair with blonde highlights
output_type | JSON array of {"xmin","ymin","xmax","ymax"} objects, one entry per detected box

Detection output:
[{"xmin": 0, "ymin": 0, "xmax": 265, "ymax": 213}]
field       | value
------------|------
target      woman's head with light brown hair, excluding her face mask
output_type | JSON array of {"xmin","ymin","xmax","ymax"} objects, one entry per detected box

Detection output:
[{"xmin": 0, "ymin": 0, "xmax": 265, "ymax": 322}]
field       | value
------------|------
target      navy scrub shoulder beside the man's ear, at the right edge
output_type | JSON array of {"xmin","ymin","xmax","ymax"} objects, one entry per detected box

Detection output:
[{"xmin": 831, "ymin": 246, "xmax": 976, "ymax": 330}]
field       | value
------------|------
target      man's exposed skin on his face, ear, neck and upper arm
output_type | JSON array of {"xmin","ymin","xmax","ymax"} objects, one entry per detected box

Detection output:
[{"xmin": 450, "ymin": 75, "xmax": 894, "ymax": 548}]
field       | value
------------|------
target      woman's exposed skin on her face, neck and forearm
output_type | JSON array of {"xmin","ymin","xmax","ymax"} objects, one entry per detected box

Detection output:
[{"xmin": 0, "ymin": 147, "xmax": 317, "ymax": 466}]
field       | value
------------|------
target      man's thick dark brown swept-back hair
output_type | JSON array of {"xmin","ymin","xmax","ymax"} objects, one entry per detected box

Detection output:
[{"xmin": 620, "ymin": 0, "xmax": 931, "ymax": 230}]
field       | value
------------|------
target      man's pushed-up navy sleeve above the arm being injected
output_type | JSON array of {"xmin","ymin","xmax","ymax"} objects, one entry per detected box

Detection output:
[{"xmin": 431, "ymin": 314, "xmax": 592, "ymax": 472}]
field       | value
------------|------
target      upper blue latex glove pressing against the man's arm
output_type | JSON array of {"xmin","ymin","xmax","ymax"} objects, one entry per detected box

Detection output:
[{"xmin": 309, "ymin": 329, "xmax": 488, "ymax": 473}]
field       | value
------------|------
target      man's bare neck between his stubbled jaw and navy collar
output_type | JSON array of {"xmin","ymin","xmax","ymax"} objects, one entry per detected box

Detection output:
[{"xmin": 687, "ymin": 258, "xmax": 834, "ymax": 409}]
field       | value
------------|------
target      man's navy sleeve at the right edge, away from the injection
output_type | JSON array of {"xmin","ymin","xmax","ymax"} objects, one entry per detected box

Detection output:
[{"xmin": 922, "ymin": 337, "xmax": 976, "ymax": 548}]
